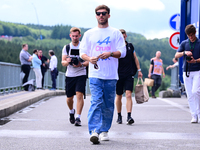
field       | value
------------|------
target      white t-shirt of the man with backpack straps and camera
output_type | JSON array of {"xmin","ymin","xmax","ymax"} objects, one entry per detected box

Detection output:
[{"xmin": 62, "ymin": 42, "xmax": 86, "ymax": 77}]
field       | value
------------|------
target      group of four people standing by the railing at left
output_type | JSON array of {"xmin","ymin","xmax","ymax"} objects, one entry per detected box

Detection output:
[{"xmin": 19, "ymin": 44, "xmax": 58, "ymax": 91}]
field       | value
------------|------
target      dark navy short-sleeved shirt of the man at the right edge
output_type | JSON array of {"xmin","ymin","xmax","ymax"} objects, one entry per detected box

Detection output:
[{"xmin": 178, "ymin": 38, "xmax": 200, "ymax": 72}]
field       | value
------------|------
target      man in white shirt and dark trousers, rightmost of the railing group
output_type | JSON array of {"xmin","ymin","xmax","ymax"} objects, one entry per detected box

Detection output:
[{"xmin": 49, "ymin": 50, "xmax": 58, "ymax": 90}]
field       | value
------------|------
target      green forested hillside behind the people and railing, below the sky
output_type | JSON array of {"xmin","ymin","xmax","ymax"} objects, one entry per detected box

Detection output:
[{"xmin": 0, "ymin": 21, "xmax": 176, "ymax": 89}]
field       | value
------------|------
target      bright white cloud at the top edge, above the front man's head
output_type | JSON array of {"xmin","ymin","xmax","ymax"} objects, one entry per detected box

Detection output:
[{"xmin": 95, "ymin": 0, "xmax": 165, "ymax": 11}]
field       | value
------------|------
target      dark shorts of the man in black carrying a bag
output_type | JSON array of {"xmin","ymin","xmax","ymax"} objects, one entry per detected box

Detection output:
[{"xmin": 116, "ymin": 76, "xmax": 134, "ymax": 95}]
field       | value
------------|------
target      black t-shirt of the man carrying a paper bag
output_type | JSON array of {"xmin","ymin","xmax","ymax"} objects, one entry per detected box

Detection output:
[{"xmin": 118, "ymin": 42, "xmax": 134, "ymax": 78}]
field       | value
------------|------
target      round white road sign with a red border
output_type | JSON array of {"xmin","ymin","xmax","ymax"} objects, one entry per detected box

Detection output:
[{"xmin": 169, "ymin": 32, "xmax": 180, "ymax": 50}]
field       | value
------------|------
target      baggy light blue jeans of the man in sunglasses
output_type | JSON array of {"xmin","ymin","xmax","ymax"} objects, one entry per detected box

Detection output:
[{"xmin": 88, "ymin": 78, "xmax": 117, "ymax": 134}]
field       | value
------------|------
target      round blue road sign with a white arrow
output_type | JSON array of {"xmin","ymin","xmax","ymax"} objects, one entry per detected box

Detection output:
[{"xmin": 169, "ymin": 14, "xmax": 180, "ymax": 31}]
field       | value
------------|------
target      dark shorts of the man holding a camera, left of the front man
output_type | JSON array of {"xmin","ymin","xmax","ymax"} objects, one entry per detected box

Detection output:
[{"xmin": 65, "ymin": 75, "xmax": 86, "ymax": 97}]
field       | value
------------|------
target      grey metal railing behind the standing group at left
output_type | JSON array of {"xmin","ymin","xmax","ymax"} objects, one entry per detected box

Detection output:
[{"xmin": 0, "ymin": 62, "xmax": 65, "ymax": 94}]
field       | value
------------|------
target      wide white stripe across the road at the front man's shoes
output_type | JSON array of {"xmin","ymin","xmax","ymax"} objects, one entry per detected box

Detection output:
[{"xmin": 0, "ymin": 130, "xmax": 200, "ymax": 140}]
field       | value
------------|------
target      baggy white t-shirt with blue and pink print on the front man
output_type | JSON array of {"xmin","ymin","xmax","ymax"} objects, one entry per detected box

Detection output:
[{"xmin": 79, "ymin": 27, "xmax": 126, "ymax": 80}]
